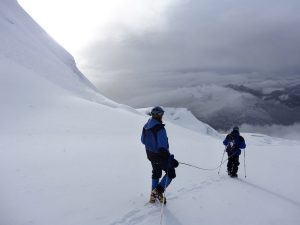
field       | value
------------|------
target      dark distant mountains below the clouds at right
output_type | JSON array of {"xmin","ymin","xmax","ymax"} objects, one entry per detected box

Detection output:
[{"xmin": 198, "ymin": 84, "xmax": 300, "ymax": 130}]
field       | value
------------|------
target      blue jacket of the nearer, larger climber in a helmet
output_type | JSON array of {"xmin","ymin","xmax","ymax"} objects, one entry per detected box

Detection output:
[{"xmin": 141, "ymin": 118, "xmax": 169, "ymax": 153}]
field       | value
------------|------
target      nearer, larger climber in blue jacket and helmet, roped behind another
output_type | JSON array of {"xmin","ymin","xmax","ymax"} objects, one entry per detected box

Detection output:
[{"xmin": 141, "ymin": 106, "xmax": 178, "ymax": 203}]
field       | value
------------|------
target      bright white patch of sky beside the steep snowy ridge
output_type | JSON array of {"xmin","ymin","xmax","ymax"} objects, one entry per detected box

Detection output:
[{"xmin": 18, "ymin": 0, "xmax": 174, "ymax": 55}]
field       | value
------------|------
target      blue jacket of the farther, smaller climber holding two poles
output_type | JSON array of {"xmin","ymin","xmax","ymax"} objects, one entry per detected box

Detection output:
[{"xmin": 223, "ymin": 131, "xmax": 246, "ymax": 156}]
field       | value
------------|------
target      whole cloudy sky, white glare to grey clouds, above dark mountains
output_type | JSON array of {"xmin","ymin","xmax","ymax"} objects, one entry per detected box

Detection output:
[{"xmin": 19, "ymin": 0, "xmax": 300, "ymax": 134}]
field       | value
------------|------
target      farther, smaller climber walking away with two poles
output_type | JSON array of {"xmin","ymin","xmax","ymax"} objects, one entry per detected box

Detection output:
[{"xmin": 223, "ymin": 127, "xmax": 246, "ymax": 177}]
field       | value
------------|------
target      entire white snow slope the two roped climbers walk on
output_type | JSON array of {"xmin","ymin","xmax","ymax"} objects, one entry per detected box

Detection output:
[{"xmin": 0, "ymin": 0, "xmax": 300, "ymax": 225}]
